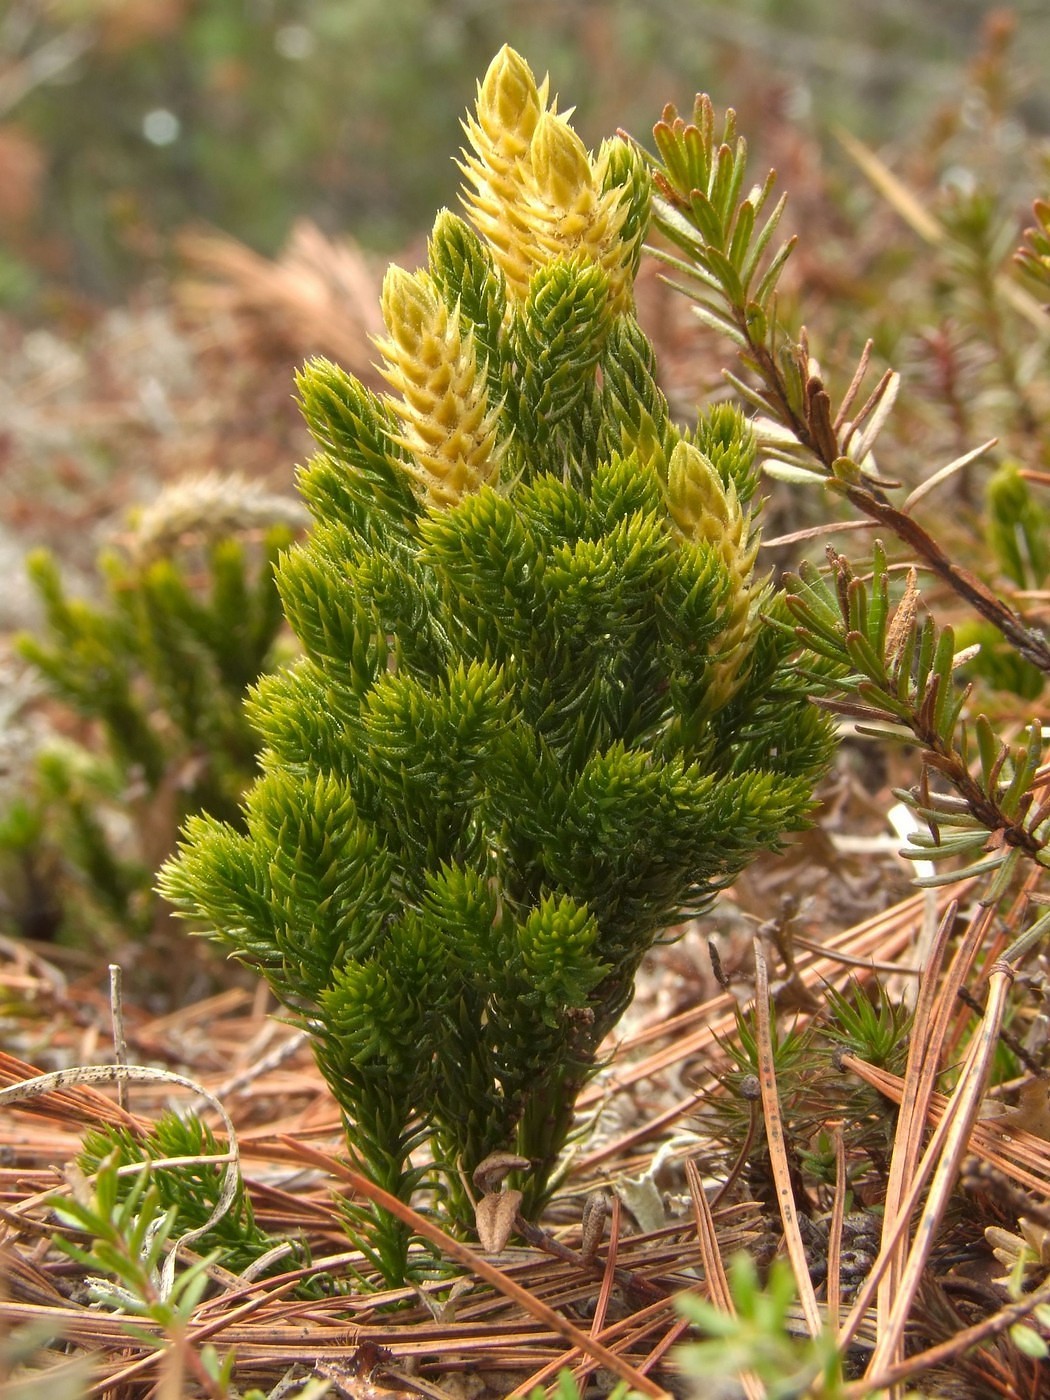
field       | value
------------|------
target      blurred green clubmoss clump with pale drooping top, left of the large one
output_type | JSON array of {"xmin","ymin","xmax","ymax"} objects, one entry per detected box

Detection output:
[{"xmin": 0, "ymin": 479, "xmax": 294, "ymax": 939}]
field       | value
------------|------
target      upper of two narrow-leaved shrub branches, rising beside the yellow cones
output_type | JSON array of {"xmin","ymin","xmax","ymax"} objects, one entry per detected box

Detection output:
[{"xmin": 652, "ymin": 94, "xmax": 1050, "ymax": 672}]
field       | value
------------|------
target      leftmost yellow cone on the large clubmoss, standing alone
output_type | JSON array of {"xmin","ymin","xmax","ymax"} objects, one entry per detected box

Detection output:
[{"xmin": 379, "ymin": 266, "xmax": 503, "ymax": 507}]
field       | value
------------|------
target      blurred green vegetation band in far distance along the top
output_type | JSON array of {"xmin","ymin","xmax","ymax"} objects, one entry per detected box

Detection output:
[{"xmin": 0, "ymin": 0, "xmax": 1050, "ymax": 308}]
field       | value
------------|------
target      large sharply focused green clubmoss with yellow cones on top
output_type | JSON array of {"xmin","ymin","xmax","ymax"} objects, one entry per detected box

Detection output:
[{"xmin": 162, "ymin": 49, "xmax": 829, "ymax": 1280}]
